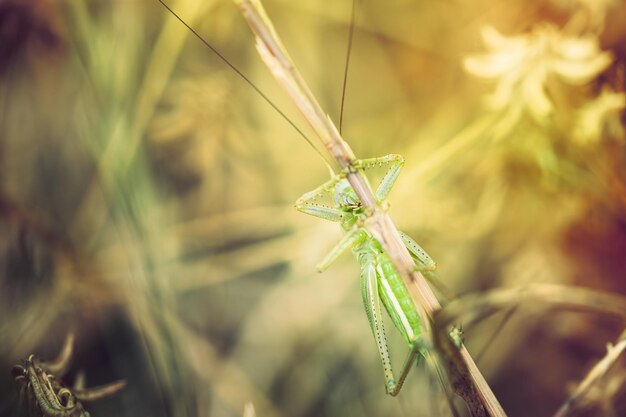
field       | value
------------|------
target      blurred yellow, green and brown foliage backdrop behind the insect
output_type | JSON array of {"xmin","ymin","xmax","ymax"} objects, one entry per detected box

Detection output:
[{"xmin": 0, "ymin": 0, "xmax": 626, "ymax": 417}]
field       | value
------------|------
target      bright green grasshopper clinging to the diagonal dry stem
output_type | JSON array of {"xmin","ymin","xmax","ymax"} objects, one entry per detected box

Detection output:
[{"xmin": 296, "ymin": 155, "xmax": 436, "ymax": 396}]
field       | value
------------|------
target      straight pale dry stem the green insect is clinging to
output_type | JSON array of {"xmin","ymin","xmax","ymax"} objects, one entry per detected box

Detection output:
[{"xmin": 234, "ymin": 0, "xmax": 506, "ymax": 416}]
